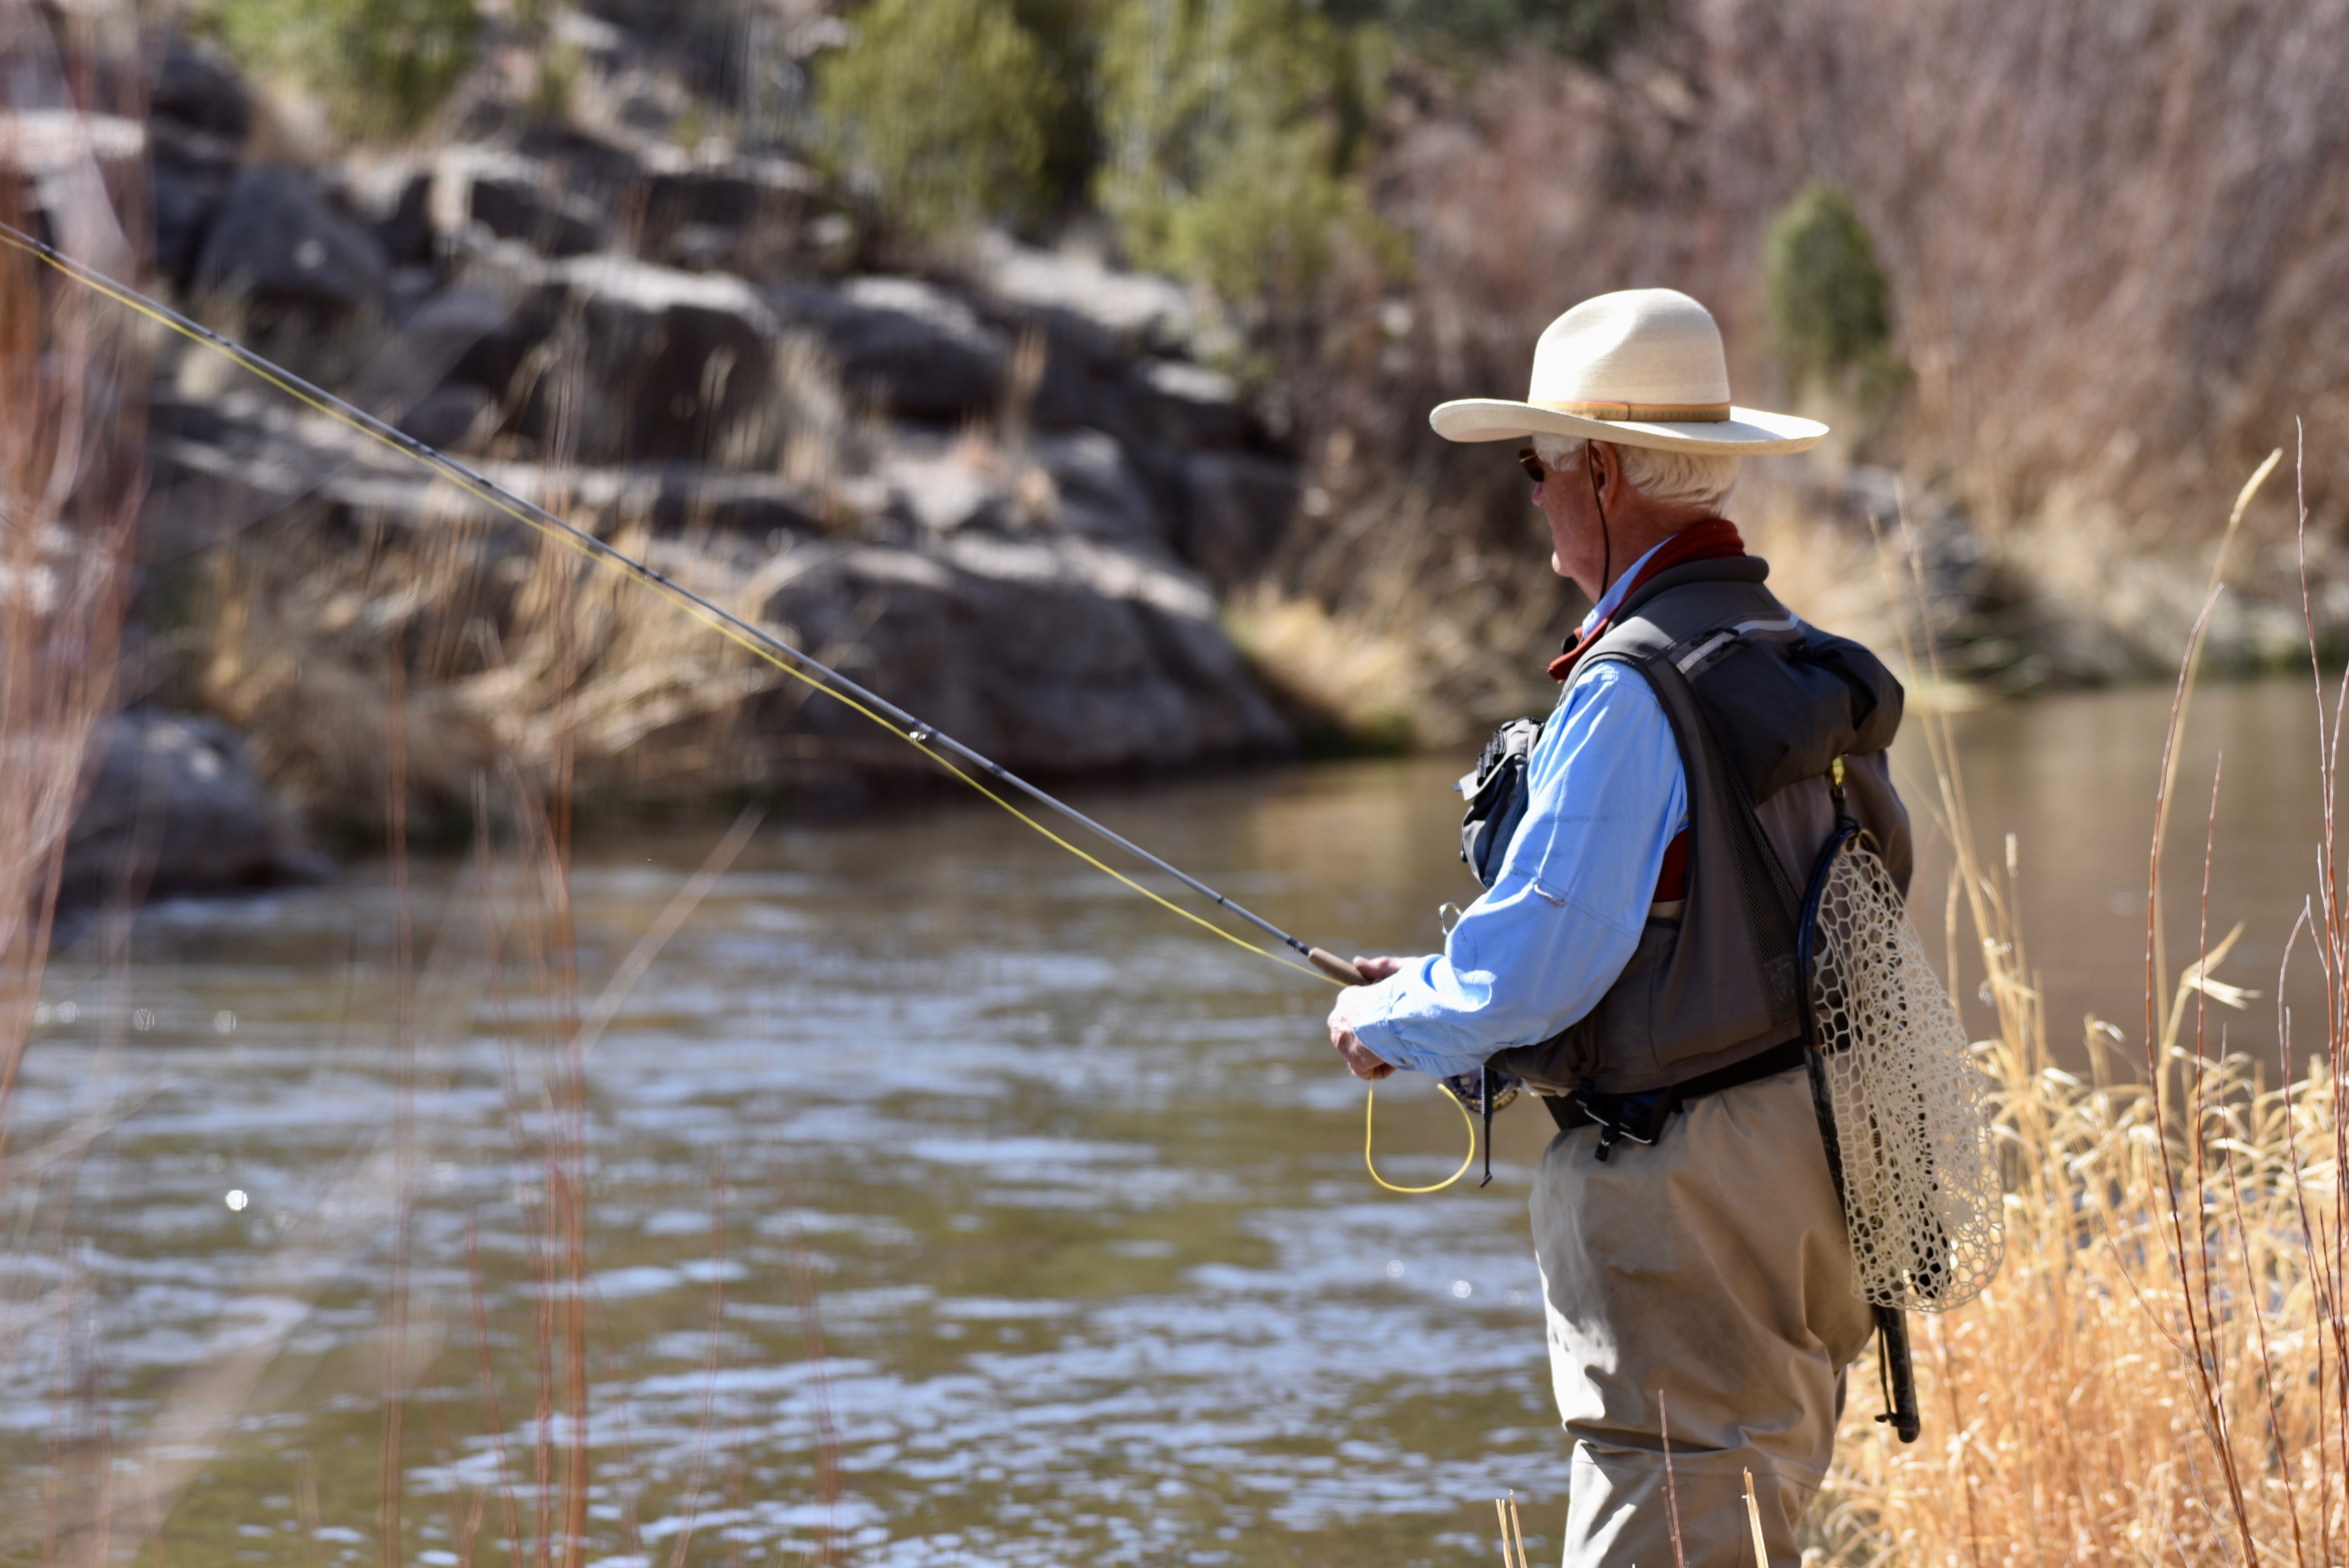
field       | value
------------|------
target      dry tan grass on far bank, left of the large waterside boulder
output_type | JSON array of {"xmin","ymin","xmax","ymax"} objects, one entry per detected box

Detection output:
[{"xmin": 195, "ymin": 486, "xmax": 817, "ymax": 833}]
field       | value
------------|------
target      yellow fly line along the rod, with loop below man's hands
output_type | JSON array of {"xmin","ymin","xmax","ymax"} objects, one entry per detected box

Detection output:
[{"xmin": 0, "ymin": 223, "xmax": 1475, "ymax": 1192}]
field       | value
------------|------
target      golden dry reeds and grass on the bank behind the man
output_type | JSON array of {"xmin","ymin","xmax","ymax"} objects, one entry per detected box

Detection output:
[{"xmin": 1813, "ymin": 469, "xmax": 2349, "ymax": 1568}]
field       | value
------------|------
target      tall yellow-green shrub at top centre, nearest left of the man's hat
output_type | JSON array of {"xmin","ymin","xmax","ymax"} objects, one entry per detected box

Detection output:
[{"xmin": 1094, "ymin": 0, "xmax": 1376, "ymax": 303}]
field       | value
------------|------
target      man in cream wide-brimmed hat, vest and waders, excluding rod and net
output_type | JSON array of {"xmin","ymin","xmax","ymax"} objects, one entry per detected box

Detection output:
[{"xmin": 1330, "ymin": 289, "xmax": 1910, "ymax": 1568}]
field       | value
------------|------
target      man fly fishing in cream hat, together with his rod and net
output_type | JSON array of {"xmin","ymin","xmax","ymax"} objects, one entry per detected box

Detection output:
[{"xmin": 0, "ymin": 211, "xmax": 2001, "ymax": 1568}]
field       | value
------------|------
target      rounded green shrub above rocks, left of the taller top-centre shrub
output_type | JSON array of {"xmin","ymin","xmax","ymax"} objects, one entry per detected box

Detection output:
[{"xmin": 815, "ymin": 0, "xmax": 1062, "ymax": 239}]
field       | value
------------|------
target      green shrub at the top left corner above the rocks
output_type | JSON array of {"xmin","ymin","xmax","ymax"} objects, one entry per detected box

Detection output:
[{"xmin": 200, "ymin": 0, "xmax": 481, "ymax": 136}]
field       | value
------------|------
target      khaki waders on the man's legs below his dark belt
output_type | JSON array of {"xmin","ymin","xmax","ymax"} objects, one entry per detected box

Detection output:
[{"xmin": 1534, "ymin": 1068, "xmax": 1875, "ymax": 1568}]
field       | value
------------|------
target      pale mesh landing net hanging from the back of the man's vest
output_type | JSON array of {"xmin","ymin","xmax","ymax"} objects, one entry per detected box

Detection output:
[{"xmin": 1811, "ymin": 840, "xmax": 2006, "ymax": 1312}]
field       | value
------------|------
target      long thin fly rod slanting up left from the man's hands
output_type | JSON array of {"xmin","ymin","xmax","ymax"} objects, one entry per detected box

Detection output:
[{"xmin": 0, "ymin": 223, "xmax": 1365, "ymax": 986}]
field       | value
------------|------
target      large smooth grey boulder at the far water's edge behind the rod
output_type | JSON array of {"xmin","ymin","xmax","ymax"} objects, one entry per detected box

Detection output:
[{"xmin": 768, "ymin": 531, "xmax": 1294, "ymax": 772}]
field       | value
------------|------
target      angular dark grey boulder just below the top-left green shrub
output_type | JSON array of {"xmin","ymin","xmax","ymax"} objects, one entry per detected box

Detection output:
[{"xmin": 195, "ymin": 169, "xmax": 388, "ymax": 312}]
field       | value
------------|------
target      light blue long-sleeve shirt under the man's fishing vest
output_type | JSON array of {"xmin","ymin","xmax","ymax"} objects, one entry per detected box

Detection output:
[{"xmin": 1355, "ymin": 545, "xmax": 1689, "ymax": 1077}]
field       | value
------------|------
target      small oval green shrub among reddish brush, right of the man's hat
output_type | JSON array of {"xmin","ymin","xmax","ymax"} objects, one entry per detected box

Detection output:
[{"xmin": 1762, "ymin": 183, "xmax": 1893, "ymax": 383}]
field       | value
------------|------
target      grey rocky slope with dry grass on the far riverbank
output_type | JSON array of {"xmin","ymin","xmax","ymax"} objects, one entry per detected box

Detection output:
[{"xmin": 91, "ymin": 16, "xmax": 1301, "ymax": 864}]
